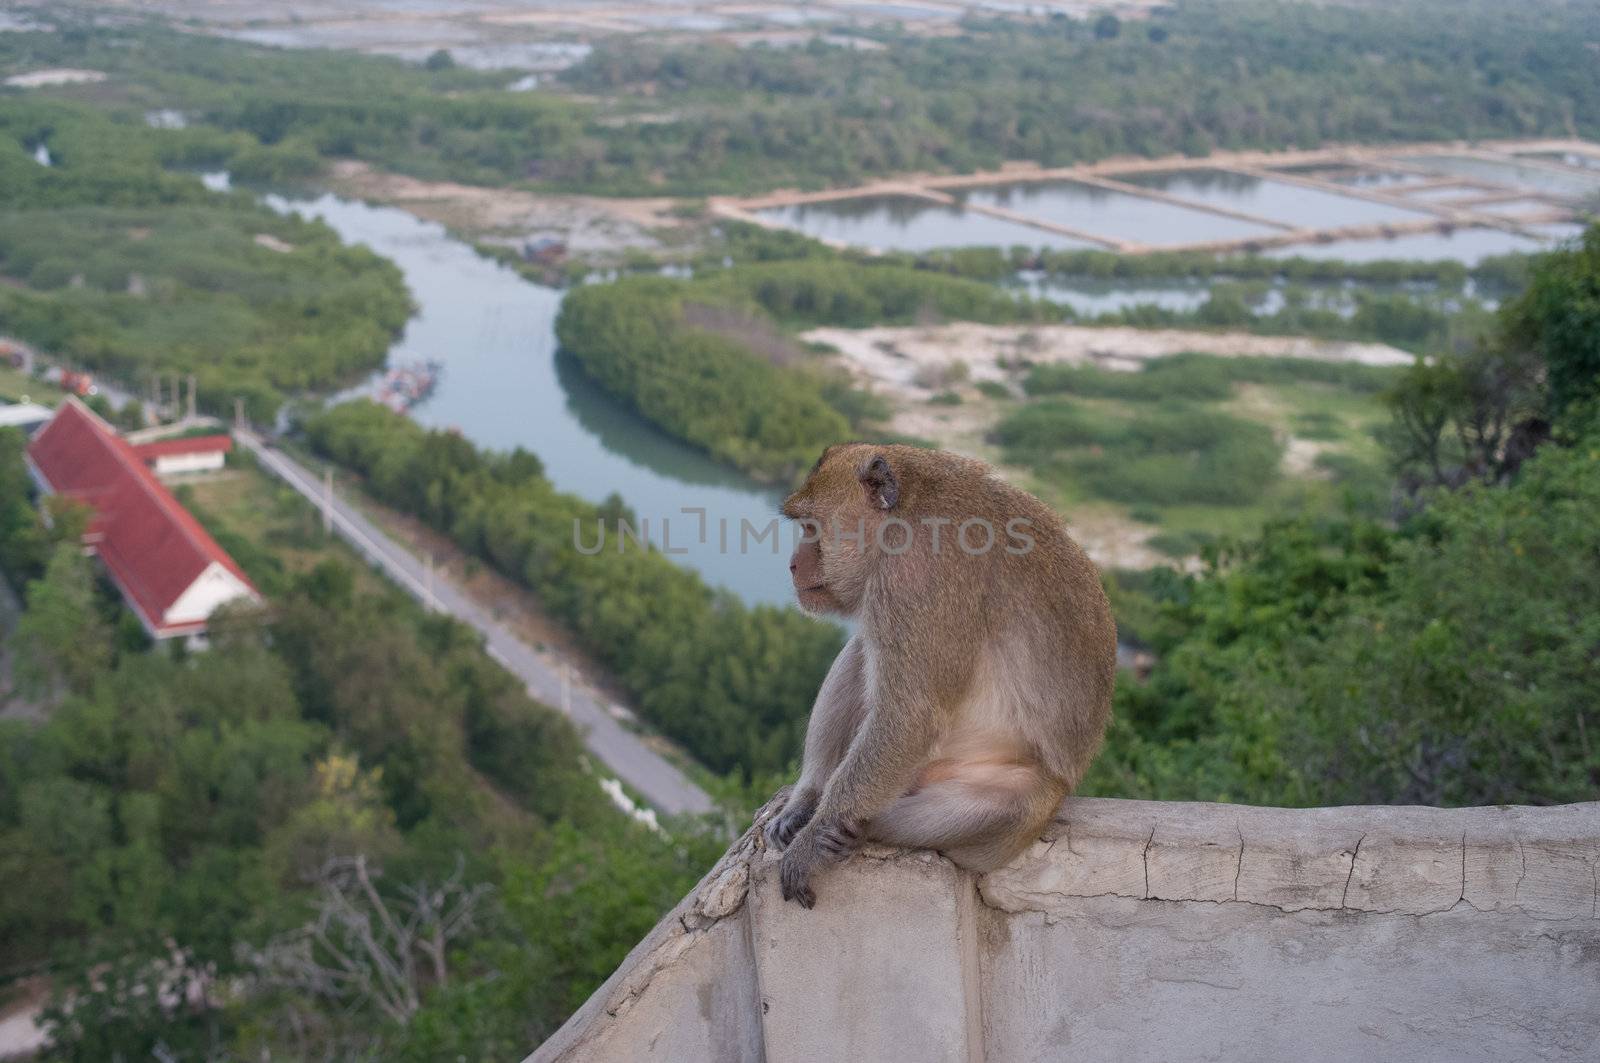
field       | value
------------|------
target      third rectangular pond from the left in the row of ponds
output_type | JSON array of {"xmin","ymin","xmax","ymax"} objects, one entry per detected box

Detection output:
[{"xmin": 1118, "ymin": 170, "xmax": 1430, "ymax": 229}]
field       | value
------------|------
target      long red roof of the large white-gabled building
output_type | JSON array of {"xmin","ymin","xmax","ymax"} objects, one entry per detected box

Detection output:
[{"xmin": 27, "ymin": 397, "xmax": 256, "ymax": 637}]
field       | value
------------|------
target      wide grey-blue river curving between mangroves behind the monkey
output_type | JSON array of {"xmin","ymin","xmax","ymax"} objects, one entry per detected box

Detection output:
[{"xmin": 267, "ymin": 195, "xmax": 794, "ymax": 604}]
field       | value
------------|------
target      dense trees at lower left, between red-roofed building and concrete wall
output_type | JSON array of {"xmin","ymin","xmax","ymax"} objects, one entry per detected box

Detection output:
[{"xmin": 0, "ymin": 431, "xmax": 722, "ymax": 1063}]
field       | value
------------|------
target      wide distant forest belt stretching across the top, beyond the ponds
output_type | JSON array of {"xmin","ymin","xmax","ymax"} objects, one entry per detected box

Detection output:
[{"xmin": 0, "ymin": 0, "xmax": 1600, "ymax": 195}]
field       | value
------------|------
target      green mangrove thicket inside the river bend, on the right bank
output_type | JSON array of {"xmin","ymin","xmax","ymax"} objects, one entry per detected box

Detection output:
[{"xmin": 555, "ymin": 259, "xmax": 1059, "ymax": 480}]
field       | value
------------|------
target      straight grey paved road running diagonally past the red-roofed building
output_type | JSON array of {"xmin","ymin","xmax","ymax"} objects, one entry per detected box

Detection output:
[{"xmin": 234, "ymin": 427, "xmax": 712, "ymax": 813}]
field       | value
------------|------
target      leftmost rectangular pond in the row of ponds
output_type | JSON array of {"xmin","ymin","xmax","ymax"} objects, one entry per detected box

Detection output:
[{"xmin": 757, "ymin": 195, "xmax": 1099, "ymax": 251}]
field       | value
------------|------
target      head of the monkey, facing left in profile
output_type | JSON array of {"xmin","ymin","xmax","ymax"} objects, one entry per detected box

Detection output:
[{"xmin": 784, "ymin": 443, "xmax": 915, "ymax": 616}]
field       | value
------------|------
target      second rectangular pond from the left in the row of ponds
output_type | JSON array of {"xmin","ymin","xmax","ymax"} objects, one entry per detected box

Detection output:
[{"xmin": 957, "ymin": 181, "xmax": 1278, "ymax": 247}]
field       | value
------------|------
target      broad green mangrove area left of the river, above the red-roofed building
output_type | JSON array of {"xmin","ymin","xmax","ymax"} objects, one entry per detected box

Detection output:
[{"xmin": 0, "ymin": 98, "xmax": 410, "ymax": 419}]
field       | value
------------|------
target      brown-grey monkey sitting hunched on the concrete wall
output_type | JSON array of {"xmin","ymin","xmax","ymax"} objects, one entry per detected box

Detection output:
[{"xmin": 766, "ymin": 443, "xmax": 1117, "ymax": 908}]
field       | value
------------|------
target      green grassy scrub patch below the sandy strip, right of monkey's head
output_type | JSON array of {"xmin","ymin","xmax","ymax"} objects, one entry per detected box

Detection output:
[{"xmin": 990, "ymin": 354, "xmax": 1397, "ymax": 559}]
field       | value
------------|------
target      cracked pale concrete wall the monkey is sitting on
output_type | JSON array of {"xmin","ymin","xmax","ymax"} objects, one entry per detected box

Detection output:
[{"xmin": 530, "ymin": 799, "xmax": 1600, "ymax": 1063}]
